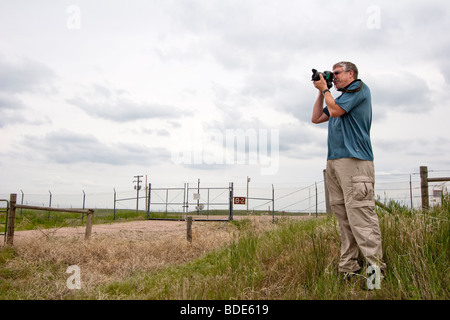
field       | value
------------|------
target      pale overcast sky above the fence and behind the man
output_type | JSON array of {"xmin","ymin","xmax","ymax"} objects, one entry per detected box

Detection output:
[{"xmin": 0, "ymin": 0, "xmax": 450, "ymax": 208}]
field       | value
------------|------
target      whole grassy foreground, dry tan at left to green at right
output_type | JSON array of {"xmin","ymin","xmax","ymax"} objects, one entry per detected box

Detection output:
[{"xmin": 0, "ymin": 202, "xmax": 450, "ymax": 300}]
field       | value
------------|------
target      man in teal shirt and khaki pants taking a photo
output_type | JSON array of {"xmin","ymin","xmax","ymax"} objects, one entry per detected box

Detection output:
[{"xmin": 312, "ymin": 61, "xmax": 386, "ymax": 279}]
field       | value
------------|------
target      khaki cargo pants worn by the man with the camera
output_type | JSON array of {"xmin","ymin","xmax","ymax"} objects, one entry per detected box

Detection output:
[{"xmin": 326, "ymin": 158, "xmax": 386, "ymax": 272}]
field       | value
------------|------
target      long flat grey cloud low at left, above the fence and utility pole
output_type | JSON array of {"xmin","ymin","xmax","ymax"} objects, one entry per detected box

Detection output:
[{"xmin": 22, "ymin": 130, "xmax": 170, "ymax": 166}]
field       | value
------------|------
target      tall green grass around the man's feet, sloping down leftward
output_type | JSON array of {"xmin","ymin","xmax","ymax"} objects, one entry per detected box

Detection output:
[{"xmin": 101, "ymin": 200, "xmax": 450, "ymax": 300}]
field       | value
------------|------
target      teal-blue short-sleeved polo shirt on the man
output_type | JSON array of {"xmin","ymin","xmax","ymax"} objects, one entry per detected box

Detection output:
[{"xmin": 323, "ymin": 80, "xmax": 373, "ymax": 161}]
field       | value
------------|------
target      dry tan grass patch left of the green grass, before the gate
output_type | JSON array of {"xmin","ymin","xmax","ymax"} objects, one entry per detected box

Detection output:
[{"xmin": 0, "ymin": 215, "xmax": 282, "ymax": 299}]
